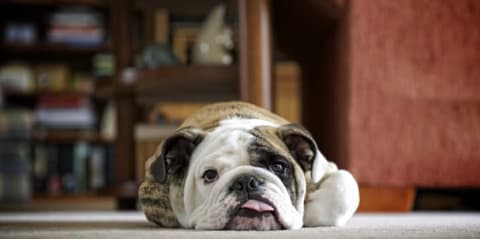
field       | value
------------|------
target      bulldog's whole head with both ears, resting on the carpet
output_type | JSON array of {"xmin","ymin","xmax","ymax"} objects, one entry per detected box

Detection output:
[{"xmin": 147, "ymin": 121, "xmax": 327, "ymax": 230}]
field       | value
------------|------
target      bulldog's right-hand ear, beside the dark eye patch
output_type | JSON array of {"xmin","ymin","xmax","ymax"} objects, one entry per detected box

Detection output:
[{"xmin": 278, "ymin": 124, "xmax": 328, "ymax": 183}]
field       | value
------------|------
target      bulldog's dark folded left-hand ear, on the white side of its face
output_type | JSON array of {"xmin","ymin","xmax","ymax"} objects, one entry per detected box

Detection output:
[{"xmin": 149, "ymin": 127, "xmax": 205, "ymax": 183}]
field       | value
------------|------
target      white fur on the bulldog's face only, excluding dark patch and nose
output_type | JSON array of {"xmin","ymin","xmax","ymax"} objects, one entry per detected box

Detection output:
[{"xmin": 179, "ymin": 119, "xmax": 305, "ymax": 229}]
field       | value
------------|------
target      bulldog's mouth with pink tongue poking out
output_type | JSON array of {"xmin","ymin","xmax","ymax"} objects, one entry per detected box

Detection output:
[{"xmin": 225, "ymin": 199, "xmax": 283, "ymax": 230}]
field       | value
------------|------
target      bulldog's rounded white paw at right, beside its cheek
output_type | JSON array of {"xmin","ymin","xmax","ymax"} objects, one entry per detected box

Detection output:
[{"xmin": 304, "ymin": 170, "xmax": 360, "ymax": 227}]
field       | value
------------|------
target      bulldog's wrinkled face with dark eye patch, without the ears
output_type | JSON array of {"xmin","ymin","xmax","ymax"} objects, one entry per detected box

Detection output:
[{"xmin": 184, "ymin": 122, "xmax": 304, "ymax": 230}]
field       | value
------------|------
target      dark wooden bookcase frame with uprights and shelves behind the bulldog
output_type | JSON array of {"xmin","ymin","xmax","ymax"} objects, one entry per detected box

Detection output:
[{"xmin": 0, "ymin": 0, "xmax": 273, "ymax": 210}]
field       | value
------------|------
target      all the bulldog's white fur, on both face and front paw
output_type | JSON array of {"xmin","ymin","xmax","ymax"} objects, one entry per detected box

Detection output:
[{"xmin": 173, "ymin": 118, "xmax": 359, "ymax": 229}]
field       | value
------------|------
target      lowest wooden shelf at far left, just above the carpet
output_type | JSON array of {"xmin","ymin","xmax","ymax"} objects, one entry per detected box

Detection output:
[{"xmin": 0, "ymin": 195, "xmax": 116, "ymax": 211}]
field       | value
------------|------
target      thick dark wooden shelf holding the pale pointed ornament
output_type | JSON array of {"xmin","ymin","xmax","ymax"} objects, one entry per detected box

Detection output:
[{"xmin": 120, "ymin": 65, "xmax": 238, "ymax": 101}]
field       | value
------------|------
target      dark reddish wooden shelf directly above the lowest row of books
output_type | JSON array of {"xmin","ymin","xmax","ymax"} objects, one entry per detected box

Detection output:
[{"xmin": 32, "ymin": 130, "xmax": 113, "ymax": 144}]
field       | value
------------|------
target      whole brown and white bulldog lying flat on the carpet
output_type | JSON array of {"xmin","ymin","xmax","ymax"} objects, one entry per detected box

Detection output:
[{"xmin": 139, "ymin": 102, "xmax": 359, "ymax": 230}]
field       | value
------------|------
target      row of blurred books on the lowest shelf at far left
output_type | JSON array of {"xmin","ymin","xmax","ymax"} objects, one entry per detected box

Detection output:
[{"xmin": 0, "ymin": 141, "xmax": 113, "ymax": 202}]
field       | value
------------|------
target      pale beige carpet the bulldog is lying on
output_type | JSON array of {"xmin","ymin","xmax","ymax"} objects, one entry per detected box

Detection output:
[{"xmin": 0, "ymin": 212, "xmax": 480, "ymax": 239}]
